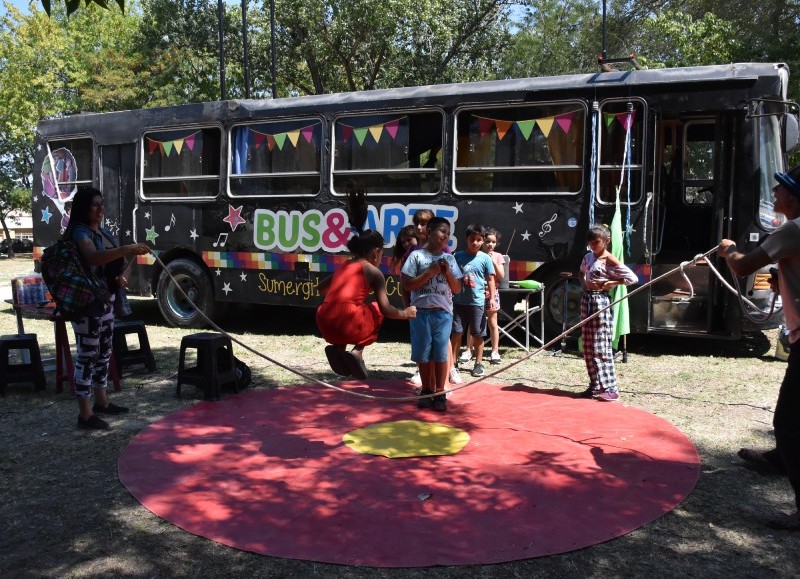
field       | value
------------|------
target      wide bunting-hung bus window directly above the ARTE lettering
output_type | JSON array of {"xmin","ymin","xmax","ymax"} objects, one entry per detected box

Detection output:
[{"xmin": 333, "ymin": 112, "xmax": 443, "ymax": 195}]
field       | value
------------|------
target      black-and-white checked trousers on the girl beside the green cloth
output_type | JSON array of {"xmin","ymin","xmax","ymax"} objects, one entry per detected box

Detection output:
[{"xmin": 581, "ymin": 292, "xmax": 617, "ymax": 392}]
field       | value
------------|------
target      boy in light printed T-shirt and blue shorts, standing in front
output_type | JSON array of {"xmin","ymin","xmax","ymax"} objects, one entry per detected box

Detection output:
[{"xmin": 401, "ymin": 217, "xmax": 461, "ymax": 412}]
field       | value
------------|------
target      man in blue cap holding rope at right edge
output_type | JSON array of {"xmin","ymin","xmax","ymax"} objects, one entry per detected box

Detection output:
[{"xmin": 719, "ymin": 166, "xmax": 800, "ymax": 531}]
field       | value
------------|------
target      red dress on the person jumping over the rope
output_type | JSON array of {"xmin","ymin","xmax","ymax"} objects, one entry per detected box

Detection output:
[{"xmin": 317, "ymin": 261, "xmax": 383, "ymax": 346}]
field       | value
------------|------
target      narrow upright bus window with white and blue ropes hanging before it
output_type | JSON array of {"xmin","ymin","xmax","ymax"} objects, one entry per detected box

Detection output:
[{"xmin": 597, "ymin": 100, "xmax": 645, "ymax": 205}]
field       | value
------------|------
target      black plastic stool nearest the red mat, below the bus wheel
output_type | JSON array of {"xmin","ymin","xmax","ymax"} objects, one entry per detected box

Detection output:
[{"xmin": 176, "ymin": 332, "xmax": 239, "ymax": 400}]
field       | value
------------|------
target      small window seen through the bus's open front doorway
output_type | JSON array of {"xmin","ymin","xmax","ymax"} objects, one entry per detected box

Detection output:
[{"xmin": 683, "ymin": 120, "xmax": 716, "ymax": 205}]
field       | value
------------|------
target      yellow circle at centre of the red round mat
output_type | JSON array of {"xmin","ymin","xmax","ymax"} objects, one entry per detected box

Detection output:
[{"xmin": 342, "ymin": 420, "xmax": 469, "ymax": 458}]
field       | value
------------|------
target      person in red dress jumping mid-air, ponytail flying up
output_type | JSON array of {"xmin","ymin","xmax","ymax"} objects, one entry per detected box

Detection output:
[{"xmin": 317, "ymin": 186, "xmax": 417, "ymax": 380}]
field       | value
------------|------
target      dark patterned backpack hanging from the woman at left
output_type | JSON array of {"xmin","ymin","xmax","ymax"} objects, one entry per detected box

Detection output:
[{"xmin": 41, "ymin": 239, "xmax": 111, "ymax": 320}]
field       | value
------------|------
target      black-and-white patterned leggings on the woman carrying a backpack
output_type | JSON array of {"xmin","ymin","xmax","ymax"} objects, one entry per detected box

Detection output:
[{"xmin": 72, "ymin": 304, "xmax": 114, "ymax": 398}]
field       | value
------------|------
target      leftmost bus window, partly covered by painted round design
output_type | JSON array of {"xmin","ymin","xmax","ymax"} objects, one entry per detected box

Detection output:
[{"xmin": 42, "ymin": 138, "xmax": 94, "ymax": 202}]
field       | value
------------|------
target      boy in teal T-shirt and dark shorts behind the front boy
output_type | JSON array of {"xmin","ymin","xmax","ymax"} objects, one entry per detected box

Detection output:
[{"xmin": 451, "ymin": 225, "xmax": 497, "ymax": 376}]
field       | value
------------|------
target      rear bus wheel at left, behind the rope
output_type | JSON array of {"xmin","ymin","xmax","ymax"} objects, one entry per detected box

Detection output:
[{"xmin": 156, "ymin": 259, "xmax": 216, "ymax": 328}]
